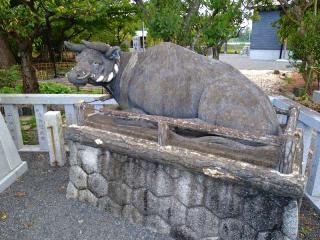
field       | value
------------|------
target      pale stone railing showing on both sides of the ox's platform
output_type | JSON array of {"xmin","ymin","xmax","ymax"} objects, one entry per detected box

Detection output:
[{"xmin": 0, "ymin": 94, "xmax": 320, "ymax": 209}]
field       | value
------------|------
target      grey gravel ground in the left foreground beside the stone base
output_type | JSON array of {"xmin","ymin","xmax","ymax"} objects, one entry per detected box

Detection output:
[{"xmin": 0, "ymin": 154, "xmax": 171, "ymax": 240}]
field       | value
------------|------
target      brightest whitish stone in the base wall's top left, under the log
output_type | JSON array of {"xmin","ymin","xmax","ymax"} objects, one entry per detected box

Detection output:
[{"xmin": 79, "ymin": 147, "xmax": 101, "ymax": 174}]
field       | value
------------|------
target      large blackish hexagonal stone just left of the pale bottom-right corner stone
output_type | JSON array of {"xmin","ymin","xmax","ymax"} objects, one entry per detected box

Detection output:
[{"xmin": 243, "ymin": 195, "xmax": 282, "ymax": 231}]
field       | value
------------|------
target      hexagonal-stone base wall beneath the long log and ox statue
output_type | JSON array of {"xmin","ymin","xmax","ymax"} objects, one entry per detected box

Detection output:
[{"xmin": 67, "ymin": 143, "xmax": 298, "ymax": 240}]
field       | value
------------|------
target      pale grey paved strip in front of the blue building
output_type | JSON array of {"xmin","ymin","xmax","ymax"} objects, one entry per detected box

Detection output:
[{"xmin": 220, "ymin": 53, "xmax": 290, "ymax": 70}]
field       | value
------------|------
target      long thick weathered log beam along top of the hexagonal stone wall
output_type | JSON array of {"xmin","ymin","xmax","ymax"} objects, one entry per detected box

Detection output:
[{"xmin": 66, "ymin": 125, "xmax": 304, "ymax": 198}]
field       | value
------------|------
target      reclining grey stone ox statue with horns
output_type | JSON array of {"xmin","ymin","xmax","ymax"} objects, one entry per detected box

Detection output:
[{"xmin": 65, "ymin": 41, "xmax": 280, "ymax": 135}]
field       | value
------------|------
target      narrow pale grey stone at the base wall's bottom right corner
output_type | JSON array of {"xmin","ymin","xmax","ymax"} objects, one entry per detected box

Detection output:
[{"xmin": 282, "ymin": 200, "xmax": 299, "ymax": 240}]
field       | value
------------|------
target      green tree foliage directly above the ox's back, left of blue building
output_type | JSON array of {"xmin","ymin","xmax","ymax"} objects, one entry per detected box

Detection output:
[{"xmin": 144, "ymin": 0, "xmax": 271, "ymax": 55}]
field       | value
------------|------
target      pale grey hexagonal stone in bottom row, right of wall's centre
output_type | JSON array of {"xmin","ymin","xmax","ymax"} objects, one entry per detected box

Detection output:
[{"xmin": 187, "ymin": 207, "xmax": 219, "ymax": 238}]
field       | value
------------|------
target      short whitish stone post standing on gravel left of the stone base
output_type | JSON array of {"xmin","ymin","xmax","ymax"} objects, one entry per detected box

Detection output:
[{"xmin": 44, "ymin": 111, "xmax": 66, "ymax": 167}]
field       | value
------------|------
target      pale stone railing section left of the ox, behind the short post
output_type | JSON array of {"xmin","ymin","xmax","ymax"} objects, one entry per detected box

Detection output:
[{"xmin": 0, "ymin": 94, "xmax": 116, "ymax": 151}]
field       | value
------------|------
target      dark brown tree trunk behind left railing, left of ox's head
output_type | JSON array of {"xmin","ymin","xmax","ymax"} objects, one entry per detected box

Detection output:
[{"xmin": 20, "ymin": 45, "xmax": 39, "ymax": 93}]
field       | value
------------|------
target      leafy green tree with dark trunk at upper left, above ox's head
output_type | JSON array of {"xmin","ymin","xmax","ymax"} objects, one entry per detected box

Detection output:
[{"xmin": 0, "ymin": 0, "xmax": 139, "ymax": 92}]
